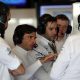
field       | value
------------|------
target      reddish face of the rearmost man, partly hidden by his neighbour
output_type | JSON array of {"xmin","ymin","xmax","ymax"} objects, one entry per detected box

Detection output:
[{"xmin": 57, "ymin": 19, "xmax": 69, "ymax": 38}]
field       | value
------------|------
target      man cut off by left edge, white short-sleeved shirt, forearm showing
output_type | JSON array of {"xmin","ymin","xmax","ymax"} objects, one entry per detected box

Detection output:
[{"xmin": 0, "ymin": 2, "xmax": 24, "ymax": 80}]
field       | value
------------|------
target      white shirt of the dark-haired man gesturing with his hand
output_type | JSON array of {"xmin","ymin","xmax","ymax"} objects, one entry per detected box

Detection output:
[{"xmin": 12, "ymin": 45, "xmax": 42, "ymax": 80}]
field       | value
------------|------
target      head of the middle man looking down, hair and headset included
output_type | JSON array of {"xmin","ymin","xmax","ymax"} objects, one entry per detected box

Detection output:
[{"xmin": 37, "ymin": 14, "xmax": 57, "ymax": 41}]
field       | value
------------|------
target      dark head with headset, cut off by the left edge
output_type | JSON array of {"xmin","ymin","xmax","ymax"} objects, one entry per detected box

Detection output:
[{"xmin": 0, "ymin": 2, "xmax": 10, "ymax": 38}]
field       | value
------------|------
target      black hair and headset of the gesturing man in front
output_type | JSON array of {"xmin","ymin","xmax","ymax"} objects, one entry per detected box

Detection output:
[{"xmin": 13, "ymin": 24, "xmax": 36, "ymax": 45}]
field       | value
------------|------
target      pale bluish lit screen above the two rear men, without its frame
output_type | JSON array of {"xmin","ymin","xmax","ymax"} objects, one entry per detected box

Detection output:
[{"xmin": 40, "ymin": 5, "xmax": 72, "ymax": 16}]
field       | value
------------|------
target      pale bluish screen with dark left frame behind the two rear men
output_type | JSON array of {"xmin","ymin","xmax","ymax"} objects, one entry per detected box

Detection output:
[{"xmin": 36, "ymin": 4, "xmax": 72, "ymax": 25}]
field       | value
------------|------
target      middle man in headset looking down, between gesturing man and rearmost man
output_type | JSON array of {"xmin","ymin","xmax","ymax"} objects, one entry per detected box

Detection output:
[{"xmin": 34, "ymin": 14, "xmax": 57, "ymax": 80}]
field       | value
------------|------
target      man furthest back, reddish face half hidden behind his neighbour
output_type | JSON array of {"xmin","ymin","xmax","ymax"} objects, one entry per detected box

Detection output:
[{"xmin": 55, "ymin": 14, "xmax": 72, "ymax": 53}]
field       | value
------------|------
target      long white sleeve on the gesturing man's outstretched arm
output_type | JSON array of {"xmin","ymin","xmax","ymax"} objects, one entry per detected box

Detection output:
[{"xmin": 17, "ymin": 60, "xmax": 42, "ymax": 80}]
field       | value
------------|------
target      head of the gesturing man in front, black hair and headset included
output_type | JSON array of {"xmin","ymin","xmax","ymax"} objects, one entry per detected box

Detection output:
[{"xmin": 13, "ymin": 24, "xmax": 36, "ymax": 50}]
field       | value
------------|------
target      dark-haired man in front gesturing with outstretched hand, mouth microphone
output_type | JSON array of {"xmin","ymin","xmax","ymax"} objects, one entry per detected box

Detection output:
[{"xmin": 13, "ymin": 24, "xmax": 53, "ymax": 80}]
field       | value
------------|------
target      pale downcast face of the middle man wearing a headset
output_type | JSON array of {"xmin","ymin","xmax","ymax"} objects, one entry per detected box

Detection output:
[{"xmin": 44, "ymin": 22, "xmax": 57, "ymax": 41}]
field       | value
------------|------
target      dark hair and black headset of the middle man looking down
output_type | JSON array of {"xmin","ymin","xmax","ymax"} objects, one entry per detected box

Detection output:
[{"xmin": 37, "ymin": 14, "xmax": 56, "ymax": 35}]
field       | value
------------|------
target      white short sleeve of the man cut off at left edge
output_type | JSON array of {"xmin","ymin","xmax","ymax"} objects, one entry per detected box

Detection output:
[{"xmin": 0, "ymin": 46, "xmax": 21, "ymax": 70}]
